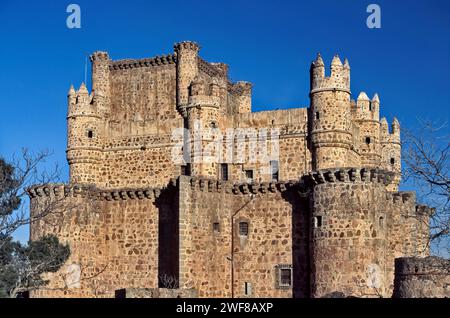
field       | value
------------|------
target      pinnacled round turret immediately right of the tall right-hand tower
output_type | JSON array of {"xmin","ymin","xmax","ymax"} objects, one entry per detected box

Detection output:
[{"xmin": 356, "ymin": 92, "xmax": 381, "ymax": 168}]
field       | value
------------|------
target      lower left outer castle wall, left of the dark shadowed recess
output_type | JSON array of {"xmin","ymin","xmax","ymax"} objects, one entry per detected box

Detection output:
[{"xmin": 27, "ymin": 186, "xmax": 175, "ymax": 297}]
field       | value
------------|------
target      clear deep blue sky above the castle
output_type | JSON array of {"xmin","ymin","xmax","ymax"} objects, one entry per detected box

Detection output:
[{"xmin": 0, "ymin": 0, "xmax": 450, "ymax": 243}]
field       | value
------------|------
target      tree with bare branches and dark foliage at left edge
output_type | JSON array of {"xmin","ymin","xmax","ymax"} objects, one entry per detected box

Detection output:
[{"xmin": 0, "ymin": 149, "xmax": 84, "ymax": 297}]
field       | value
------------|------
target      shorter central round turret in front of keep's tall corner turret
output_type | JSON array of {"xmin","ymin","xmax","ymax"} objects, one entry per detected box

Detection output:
[{"xmin": 186, "ymin": 77, "xmax": 220, "ymax": 178}]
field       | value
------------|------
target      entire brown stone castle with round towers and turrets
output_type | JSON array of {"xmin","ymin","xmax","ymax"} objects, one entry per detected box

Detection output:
[{"xmin": 29, "ymin": 42, "xmax": 429, "ymax": 297}]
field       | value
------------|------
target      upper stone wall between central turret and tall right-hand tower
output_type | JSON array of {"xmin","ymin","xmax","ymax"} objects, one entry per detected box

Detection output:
[{"xmin": 223, "ymin": 108, "xmax": 311, "ymax": 182}]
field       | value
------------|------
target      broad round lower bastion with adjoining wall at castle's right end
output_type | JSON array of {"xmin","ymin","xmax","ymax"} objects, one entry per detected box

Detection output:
[{"xmin": 309, "ymin": 169, "xmax": 428, "ymax": 297}]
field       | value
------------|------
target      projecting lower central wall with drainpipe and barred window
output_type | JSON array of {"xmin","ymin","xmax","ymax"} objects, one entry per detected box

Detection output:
[{"xmin": 180, "ymin": 177, "xmax": 309, "ymax": 297}]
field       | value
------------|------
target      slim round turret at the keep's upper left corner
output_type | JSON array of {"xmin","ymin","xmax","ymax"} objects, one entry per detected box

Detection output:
[{"xmin": 90, "ymin": 51, "xmax": 111, "ymax": 116}]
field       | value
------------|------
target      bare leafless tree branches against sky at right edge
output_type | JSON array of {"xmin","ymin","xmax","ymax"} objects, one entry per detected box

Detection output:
[{"xmin": 402, "ymin": 120, "xmax": 450, "ymax": 255}]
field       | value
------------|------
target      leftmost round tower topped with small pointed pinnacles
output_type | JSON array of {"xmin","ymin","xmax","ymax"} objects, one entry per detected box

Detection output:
[{"xmin": 67, "ymin": 83, "xmax": 104, "ymax": 184}]
